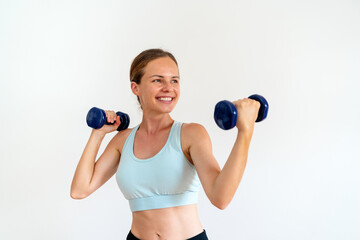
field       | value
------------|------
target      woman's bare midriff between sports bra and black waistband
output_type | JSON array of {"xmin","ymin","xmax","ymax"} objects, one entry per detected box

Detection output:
[{"xmin": 131, "ymin": 204, "xmax": 203, "ymax": 240}]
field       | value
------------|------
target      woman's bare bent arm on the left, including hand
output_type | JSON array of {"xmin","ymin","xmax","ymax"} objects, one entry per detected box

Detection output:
[{"xmin": 70, "ymin": 112, "xmax": 120, "ymax": 199}]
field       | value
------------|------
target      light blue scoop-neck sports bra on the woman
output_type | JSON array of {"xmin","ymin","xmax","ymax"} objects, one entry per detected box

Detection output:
[{"xmin": 116, "ymin": 121, "xmax": 200, "ymax": 212}]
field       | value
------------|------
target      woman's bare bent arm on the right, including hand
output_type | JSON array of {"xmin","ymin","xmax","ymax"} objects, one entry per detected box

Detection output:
[{"xmin": 188, "ymin": 99, "xmax": 260, "ymax": 210}]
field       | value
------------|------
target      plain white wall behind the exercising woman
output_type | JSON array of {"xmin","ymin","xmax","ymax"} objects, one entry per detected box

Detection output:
[{"xmin": 0, "ymin": 0, "xmax": 360, "ymax": 240}]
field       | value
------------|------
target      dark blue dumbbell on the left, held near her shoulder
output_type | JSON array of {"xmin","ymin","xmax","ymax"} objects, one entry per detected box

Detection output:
[{"xmin": 86, "ymin": 107, "xmax": 130, "ymax": 131}]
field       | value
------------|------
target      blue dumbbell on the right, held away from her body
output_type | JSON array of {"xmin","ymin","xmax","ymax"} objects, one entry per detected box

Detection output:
[{"xmin": 214, "ymin": 94, "xmax": 269, "ymax": 130}]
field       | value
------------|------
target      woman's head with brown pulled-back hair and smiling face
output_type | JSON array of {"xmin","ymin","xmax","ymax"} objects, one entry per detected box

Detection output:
[{"xmin": 130, "ymin": 49, "xmax": 180, "ymax": 113}]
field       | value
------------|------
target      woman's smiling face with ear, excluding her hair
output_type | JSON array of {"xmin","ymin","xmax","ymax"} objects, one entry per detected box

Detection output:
[{"xmin": 131, "ymin": 57, "xmax": 180, "ymax": 113}]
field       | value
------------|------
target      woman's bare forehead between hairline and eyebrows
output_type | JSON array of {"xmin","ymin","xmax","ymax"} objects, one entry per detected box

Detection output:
[{"xmin": 144, "ymin": 57, "xmax": 179, "ymax": 75}]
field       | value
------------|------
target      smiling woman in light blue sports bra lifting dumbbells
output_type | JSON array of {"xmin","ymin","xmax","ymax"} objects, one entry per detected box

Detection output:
[{"xmin": 71, "ymin": 49, "xmax": 260, "ymax": 240}]
